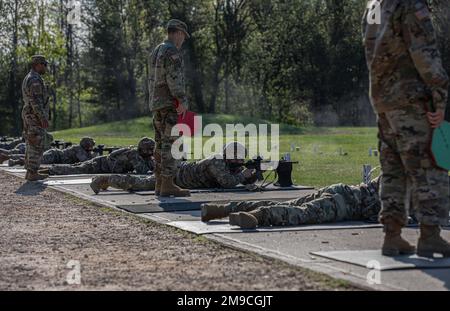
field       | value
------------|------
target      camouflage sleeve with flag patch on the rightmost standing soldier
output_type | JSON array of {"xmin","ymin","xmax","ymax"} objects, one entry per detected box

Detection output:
[{"xmin": 402, "ymin": 0, "xmax": 449, "ymax": 110}]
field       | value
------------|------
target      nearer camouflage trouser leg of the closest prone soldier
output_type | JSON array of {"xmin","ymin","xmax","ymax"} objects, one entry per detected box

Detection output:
[{"xmin": 252, "ymin": 193, "xmax": 353, "ymax": 226}]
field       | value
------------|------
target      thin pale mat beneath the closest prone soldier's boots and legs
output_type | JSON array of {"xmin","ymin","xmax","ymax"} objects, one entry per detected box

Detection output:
[{"xmin": 163, "ymin": 219, "xmax": 381, "ymax": 234}]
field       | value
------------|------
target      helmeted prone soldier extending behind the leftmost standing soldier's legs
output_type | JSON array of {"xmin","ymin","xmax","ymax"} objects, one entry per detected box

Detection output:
[{"xmin": 8, "ymin": 137, "xmax": 95, "ymax": 166}]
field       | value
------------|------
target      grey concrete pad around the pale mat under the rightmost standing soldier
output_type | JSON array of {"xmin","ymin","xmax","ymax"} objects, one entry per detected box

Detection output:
[{"xmin": 205, "ymin": 228, "xmax": 450, "ymax": 291}]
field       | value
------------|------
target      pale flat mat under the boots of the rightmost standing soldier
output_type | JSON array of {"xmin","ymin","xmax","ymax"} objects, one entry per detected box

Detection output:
[{"xmin": 311, "ymin": 250, "xmax": 450, "ymax": 270}]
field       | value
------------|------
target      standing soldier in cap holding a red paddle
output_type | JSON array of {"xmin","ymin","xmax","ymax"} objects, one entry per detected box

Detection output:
[{"xmin": 149, "ymin": 19, "xmax": 190, "ymax": 197}]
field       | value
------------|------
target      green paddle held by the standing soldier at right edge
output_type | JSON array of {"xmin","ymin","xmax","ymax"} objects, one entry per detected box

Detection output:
[{"xmin": 430, "ymin": 103, "xmax": 450, "ymax": 171}]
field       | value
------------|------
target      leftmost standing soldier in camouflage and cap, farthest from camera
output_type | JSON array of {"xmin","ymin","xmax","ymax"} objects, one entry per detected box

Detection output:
[{"xmin": 22, "ymin": 55, "xmax": 53, "ymax": 181}]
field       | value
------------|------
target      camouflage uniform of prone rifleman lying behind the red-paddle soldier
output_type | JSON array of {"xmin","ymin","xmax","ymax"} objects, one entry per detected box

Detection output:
[{"xmin": 97, "ymin": 157, "xmax": 250, "ymax": 191}]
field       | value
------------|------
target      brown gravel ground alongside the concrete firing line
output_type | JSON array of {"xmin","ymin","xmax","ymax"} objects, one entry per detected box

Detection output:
[{"xmin": 0, "ymin": 172, "xmax": 355, "ymax": 290}]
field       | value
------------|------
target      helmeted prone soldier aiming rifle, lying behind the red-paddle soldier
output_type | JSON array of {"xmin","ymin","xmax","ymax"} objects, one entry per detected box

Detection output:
[{"xmin": 91, "ymin": 145, "xmax": 256, "ymax": 195}]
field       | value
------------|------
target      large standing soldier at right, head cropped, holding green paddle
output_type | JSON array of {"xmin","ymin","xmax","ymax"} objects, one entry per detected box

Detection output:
[{"xmin": 363, "ymin": 0, "xmax": 450, "ymax": 256}]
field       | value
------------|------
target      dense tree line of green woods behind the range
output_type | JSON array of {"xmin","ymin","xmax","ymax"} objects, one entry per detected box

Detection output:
[{"xmin": 0, "ymin": 0, "xmax": 450, "ymax": 134}]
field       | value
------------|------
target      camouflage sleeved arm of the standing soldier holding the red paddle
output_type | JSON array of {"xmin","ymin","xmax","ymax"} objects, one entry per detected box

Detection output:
[{"xmin": 165, "ymin": 51, "xmax": 188, "ymax": 109}]
